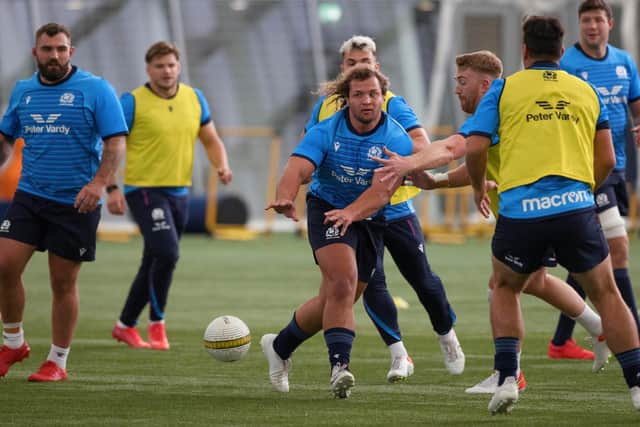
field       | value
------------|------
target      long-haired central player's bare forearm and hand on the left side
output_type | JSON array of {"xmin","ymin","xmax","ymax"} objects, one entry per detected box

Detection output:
[{"xmin": 265, "ymin": 156, "xmax": 315, "ymax": 221}]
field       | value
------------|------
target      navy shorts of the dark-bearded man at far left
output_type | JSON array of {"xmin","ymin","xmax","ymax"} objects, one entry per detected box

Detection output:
[{"xmin": 0, "ymin": 191, "xmax": 100, "ymax": 261}]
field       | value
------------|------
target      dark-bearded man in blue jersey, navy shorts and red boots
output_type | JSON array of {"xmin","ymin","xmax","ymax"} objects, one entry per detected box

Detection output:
[{"xmin": 0, "ymin": 23, "xmax": 128, "ymax": 382}]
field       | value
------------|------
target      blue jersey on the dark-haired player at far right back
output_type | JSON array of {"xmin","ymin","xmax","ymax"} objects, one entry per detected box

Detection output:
[{"xmin": 560, "ymin": 43, "xmax": 640, "ymax": 169}]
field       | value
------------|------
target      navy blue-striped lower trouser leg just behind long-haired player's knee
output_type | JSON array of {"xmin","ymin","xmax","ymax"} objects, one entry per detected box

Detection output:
[{"xmin": 362, "ymin": 282, "xmax": 402, "ymax": 346}]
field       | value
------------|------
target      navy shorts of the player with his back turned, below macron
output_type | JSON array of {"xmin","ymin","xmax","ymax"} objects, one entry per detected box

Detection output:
[{"xmin": 491, "ymin": 208, "xmax": 609, "ymax": 273}]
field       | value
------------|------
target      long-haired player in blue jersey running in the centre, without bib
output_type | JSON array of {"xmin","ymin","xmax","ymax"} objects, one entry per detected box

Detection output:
[{"xmin": 260, "ymin": 64, "xmax": 412, "ymax": 399}]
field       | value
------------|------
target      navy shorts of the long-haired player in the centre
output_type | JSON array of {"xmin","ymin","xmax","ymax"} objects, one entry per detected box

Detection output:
[{"xmin": 307, "ymin": 194, "xmax": 384, "ymax": 282}]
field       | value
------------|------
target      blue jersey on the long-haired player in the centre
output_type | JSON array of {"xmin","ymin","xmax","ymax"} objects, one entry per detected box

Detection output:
[{"xmin": 292, "ymin": 108, "xmax": 413, "ymax": 209}]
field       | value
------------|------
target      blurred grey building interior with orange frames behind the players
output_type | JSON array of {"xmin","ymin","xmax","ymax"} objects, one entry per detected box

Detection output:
[{"xmin": 0, "ymin": 0, "xmax": 640, "ymax": 241}]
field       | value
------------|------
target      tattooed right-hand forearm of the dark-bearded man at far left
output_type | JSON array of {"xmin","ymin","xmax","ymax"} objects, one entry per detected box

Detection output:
[{"xmin": 73, "ymin": 135, "xmax": 125, "ymax": 213}]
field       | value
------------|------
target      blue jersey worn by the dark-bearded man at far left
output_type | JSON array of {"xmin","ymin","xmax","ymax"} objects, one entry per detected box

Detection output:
[{"xmin": 0, "ymin": 66, "xmax": 128, "ymax": 204}]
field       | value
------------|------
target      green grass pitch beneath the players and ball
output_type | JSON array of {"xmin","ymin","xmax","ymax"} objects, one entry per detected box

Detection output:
[{"xmin": 0, "ymin": 235, "xmax": 640, "ymax": 426}]
